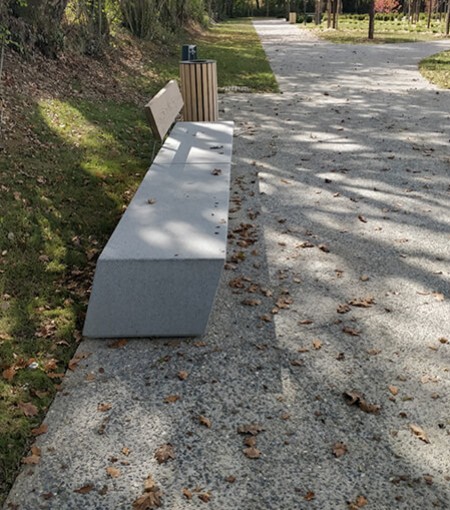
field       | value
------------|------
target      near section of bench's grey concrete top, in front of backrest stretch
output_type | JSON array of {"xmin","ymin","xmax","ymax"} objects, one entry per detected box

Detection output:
[{"xmin": 100, "ymin": 164, "xmax": 231, "ymax": 260}]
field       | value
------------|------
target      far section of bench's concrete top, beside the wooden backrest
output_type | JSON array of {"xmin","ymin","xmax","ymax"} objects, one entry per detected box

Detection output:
[{"xmin": 154, "ymin": 121, "xmax": 234, "ymax": 165}]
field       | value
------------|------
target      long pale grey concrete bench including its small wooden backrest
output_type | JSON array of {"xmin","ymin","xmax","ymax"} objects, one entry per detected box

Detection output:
[{"xmin": 83, "ymin": 82, "xmax": 234, "ymax": 338}]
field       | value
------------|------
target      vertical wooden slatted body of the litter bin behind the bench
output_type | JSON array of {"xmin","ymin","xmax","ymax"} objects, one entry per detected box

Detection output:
[{"xmin": 180, "ymin": 60, "xmax": 219, "ymax": 122}]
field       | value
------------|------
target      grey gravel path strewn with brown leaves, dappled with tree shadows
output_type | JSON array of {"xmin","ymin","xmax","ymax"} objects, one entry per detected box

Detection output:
[{"xmin": 5, "ymin": 16, "xmax": 450, "ymax": 510}]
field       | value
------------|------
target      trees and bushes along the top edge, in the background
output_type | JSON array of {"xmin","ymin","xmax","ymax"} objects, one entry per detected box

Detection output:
[{"xmin": 0, "ymin": 0, "xmax": 450, "ymax": 56}]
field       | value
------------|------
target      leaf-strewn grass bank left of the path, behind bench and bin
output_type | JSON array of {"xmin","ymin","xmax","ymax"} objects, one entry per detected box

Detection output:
[{"xmin": 0, "ymin": 17, "xmax": 277, "ymax": 505}]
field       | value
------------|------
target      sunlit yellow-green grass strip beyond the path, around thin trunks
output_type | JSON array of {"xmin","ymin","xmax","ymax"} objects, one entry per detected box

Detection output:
[{"xmin": 309, "ymin": 15, "xmax": 450, "ymax": 44}]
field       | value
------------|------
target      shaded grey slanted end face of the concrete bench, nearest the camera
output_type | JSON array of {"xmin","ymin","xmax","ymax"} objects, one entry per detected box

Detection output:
[{"xmin": 83, "ymin": 259, "xmax": 223, "ymax": 338}]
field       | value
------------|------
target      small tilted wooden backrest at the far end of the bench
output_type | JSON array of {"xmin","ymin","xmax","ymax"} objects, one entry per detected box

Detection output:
[{"xmin": 145, "ymin": 80, "xmax": 184, "ymax": 141}]
